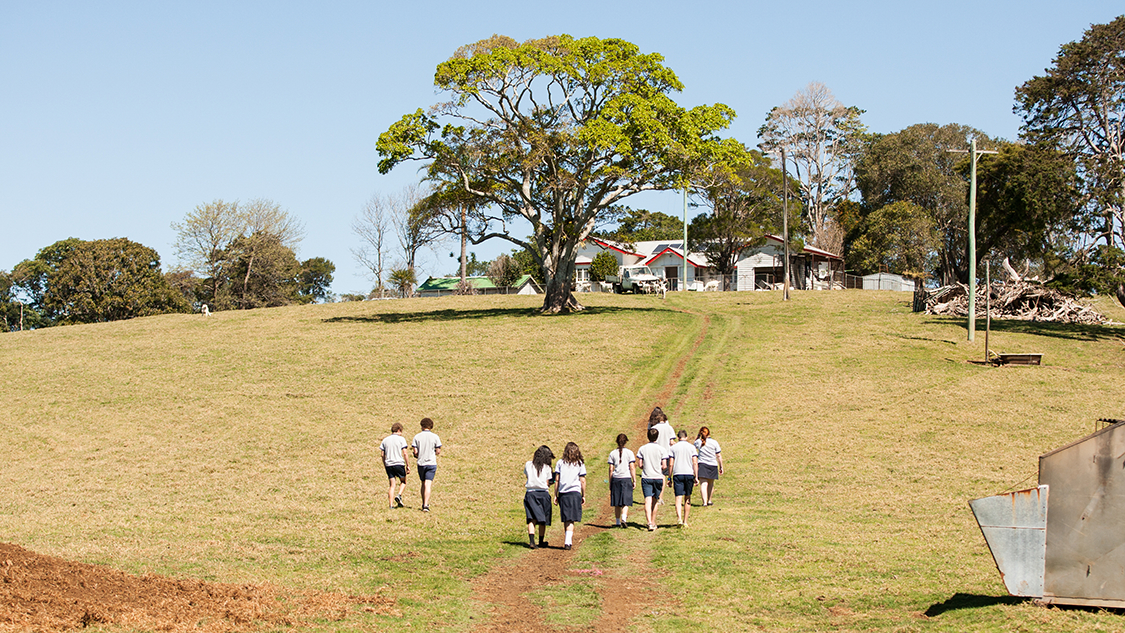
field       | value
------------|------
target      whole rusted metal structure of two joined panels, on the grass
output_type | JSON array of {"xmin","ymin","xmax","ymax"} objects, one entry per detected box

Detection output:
[{"xmin": 969, "ymin": 421, "xmax": 1125, "ymax": 608}]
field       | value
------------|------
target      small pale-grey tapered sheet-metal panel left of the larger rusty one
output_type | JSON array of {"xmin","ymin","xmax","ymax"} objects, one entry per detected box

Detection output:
[{"xmin": 969, "ymin": 486, "xmax": 1049, "ymax": 597}]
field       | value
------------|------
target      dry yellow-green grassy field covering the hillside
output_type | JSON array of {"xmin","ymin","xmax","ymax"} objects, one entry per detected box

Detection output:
[{"xmin": 0, "ymin": 291, "xmax": 1125, "ymax": 631}]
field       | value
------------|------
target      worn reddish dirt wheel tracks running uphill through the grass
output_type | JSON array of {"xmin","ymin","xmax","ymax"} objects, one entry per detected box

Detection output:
[{"xmin": 473, "ymin": 308, "xmax": 711, "ymax": 633}]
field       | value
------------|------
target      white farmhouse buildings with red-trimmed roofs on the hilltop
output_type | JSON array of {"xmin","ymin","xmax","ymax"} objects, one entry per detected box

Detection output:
[{"xmin": 576, "ymin": 235, "xmax": 844, "ymax": 290}]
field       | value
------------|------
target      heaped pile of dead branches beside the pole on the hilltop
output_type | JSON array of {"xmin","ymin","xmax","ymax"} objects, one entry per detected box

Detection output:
[{"xmin": 926, "ymin": 280, "xmax": 1109, "ymax": 325}]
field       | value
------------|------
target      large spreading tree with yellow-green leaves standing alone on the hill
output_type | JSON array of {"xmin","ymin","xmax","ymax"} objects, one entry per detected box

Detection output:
[{"xmin": 376, "ymin": 35, "xmax": 738, "ymax": 313}]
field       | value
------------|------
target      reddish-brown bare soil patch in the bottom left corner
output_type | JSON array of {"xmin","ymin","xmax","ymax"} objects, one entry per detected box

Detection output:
[{"xmin": 0, "ymin": 543, "xmax": 398, "ymax": 633}]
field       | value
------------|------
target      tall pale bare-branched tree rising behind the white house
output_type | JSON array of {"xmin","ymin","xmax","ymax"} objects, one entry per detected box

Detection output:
[{"xmin": 758, "ymin": 82, "xmax": 866, "ymax": 250}]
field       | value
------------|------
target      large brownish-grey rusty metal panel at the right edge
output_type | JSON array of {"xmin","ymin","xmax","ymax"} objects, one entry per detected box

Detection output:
[{"xmin": 1040, "ymin": 424, "xmax": 1125, "ymax": 604}]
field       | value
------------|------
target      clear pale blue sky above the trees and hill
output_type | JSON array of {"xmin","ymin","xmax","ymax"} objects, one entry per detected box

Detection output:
[{"xmin": 0, "ymin": 0, "xmax": 1125, "ymax": 292}]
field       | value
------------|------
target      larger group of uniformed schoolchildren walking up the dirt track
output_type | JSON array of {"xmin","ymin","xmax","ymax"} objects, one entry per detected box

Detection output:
[{"xmin": 523, "ymin": 407, "xmax": 722, "ymax": 550}]
